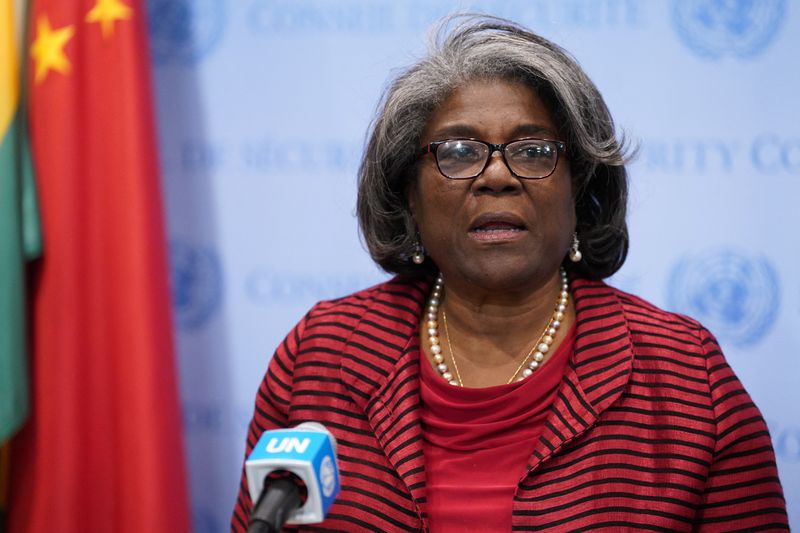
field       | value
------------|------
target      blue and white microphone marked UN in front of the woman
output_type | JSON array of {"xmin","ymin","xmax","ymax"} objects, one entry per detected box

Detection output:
[{"xmin": 245, "ymin": 422, "xmax": 340, "ymax": 533}]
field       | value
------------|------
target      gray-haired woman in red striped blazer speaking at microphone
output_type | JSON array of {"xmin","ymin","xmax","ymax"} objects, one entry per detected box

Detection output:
[{"xmin": 232, "ymin": 17, "xmax": 787, "ymax": 532}]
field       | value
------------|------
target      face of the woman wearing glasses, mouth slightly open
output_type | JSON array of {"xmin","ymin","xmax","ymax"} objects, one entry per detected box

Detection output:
[{"xmin": 408, "ymin": 80, "xmax": 575, "ymax": 291}]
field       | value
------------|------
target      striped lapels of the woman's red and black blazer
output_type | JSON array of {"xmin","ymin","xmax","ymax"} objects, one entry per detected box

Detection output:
[{"xmin": 341, "ymin": 277, "xmax": 633, "ymax": 516}]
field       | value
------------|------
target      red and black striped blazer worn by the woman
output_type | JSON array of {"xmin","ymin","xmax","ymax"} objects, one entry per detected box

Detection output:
[{"xmin": 231, "ymin": 277, "xmax": 788, "ymax": 532}]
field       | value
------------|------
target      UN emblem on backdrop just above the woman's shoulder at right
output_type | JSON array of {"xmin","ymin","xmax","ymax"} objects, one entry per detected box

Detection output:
[{"xmin": 667, "ymin": 250, "xmax": 780, "ymax": 346}]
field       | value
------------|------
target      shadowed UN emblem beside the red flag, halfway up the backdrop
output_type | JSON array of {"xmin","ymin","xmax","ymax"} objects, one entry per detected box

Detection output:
[{"xmin": 169, "ymin": 241, "xmax": 222, "ymax": 330}]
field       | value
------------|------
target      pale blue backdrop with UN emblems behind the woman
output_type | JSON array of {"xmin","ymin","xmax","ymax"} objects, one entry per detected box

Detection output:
[{"xmin": 149, "ymin": 0, "xmax": 800, "ymax": 533}]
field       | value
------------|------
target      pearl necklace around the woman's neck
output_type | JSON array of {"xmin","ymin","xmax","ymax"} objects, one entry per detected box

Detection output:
[{"xmin": 425, "ymin": 267, "xmax": 569, "ymax": 387}]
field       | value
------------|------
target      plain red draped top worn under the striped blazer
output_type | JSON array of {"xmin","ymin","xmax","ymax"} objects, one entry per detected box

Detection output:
[{"xmin": 420, "ymin": 327, "xmax": 575, "ymax": 533}]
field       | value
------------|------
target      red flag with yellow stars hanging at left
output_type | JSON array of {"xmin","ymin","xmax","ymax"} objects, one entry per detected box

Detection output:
[{"xmin": 9, "ymin": 0, "xmax": 190, "ymax": 533}]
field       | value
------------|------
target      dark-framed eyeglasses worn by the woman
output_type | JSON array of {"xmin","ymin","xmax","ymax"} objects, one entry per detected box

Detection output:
[{"xmin": 419, "ymin": 139, "xmax": 567, "ymax": 180}]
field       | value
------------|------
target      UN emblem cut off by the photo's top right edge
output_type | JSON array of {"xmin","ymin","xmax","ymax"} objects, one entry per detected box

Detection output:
[{"xmin": 672, "ymin": 0, "xmax": 786, "ymax": 59}]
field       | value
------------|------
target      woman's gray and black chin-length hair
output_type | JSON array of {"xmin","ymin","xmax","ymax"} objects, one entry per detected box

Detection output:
[{"xmin": 357, "ymin": 14, "xmax": 628, "ymax": 279}]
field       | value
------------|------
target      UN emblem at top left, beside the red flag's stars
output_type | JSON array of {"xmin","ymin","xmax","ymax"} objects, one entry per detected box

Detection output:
[{"xmin": 147, "ymin": 0, "xmax": 226, "ymax": 64}]
